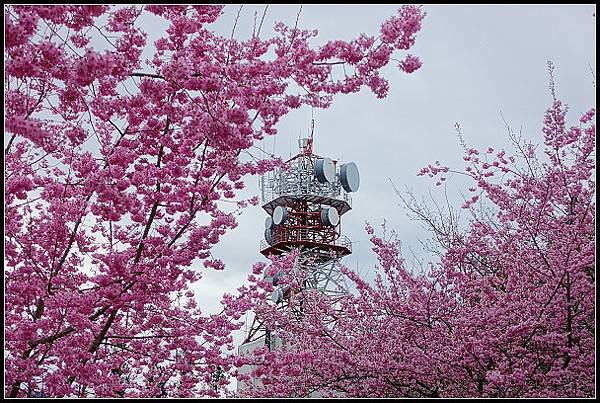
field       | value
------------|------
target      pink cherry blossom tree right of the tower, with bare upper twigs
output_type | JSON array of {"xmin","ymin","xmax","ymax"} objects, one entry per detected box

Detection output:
[{"xmin": 239, "ymin": 74, "xmax": 596, "ymax": 397}]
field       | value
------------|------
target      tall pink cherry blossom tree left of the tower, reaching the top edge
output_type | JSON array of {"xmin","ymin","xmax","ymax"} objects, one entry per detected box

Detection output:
[{"xmin": 4, "ymin": 5, "xmax": 424, "ymax": 397}]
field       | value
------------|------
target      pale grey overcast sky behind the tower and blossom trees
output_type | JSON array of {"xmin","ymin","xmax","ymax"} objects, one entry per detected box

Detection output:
[{"xmin": 196, "ymin": 5, "xmax": 596, "ymax": 328}]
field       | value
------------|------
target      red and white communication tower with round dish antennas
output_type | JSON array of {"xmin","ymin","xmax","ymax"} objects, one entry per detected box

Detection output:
[{"xmin": 238, "ymin": 136, "xmax": 360, "ymax": 389}]
